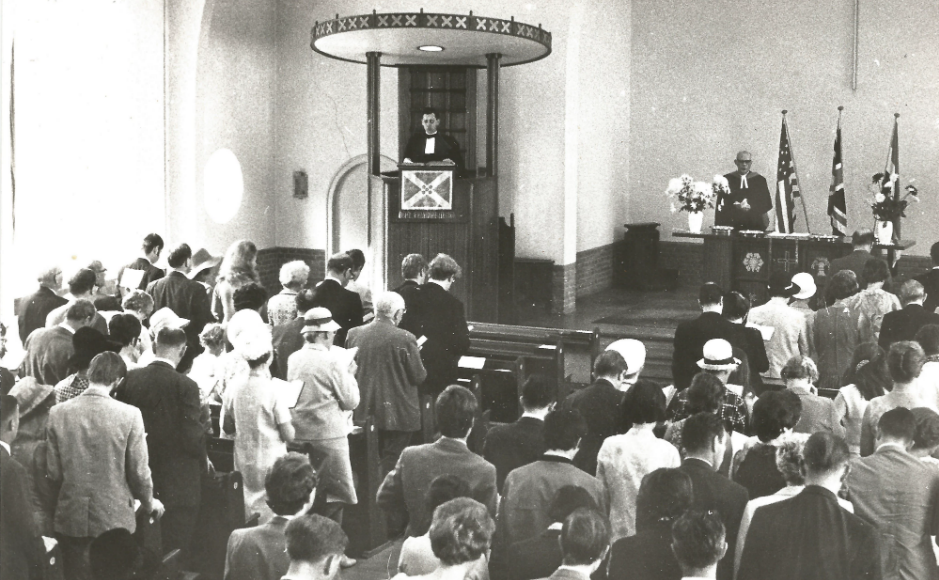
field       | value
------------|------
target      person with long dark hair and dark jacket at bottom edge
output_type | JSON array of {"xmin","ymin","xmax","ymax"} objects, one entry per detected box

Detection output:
[{"xmin": 607, "ymin": 468, "xmax": 693, "ymax": 580}]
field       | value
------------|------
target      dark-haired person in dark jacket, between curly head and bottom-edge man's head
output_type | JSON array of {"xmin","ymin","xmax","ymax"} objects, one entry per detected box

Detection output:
[{"xmin": 489, "ymin": 485, "xmax": 598, "ymax": 580}]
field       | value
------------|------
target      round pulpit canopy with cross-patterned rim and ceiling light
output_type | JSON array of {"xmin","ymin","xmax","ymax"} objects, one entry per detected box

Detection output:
[{"xmin": 310, "ymin": 10, "xmax": 551, "ymax": 68}]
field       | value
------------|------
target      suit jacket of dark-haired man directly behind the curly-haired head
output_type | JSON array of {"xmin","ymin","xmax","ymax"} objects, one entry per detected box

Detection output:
[{"xmin": 377, "ymin": 437, "xmax": 498, "ymax": 536}]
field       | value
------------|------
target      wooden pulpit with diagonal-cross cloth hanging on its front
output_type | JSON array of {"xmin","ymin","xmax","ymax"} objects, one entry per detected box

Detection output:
[{"xmin": 382, "ymin": 165, "xmax": 515, "ymax": 322}]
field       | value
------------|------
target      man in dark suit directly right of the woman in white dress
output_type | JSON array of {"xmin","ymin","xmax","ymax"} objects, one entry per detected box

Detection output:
[{"xmin": 679, "ymin": 413, "xmax": 749, "ymax": 580}]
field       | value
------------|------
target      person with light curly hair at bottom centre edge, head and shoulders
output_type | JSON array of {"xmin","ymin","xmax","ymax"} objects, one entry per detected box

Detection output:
[{"xmin": 395, "ymin": 497, "xmax": 495, "ymax": 580}]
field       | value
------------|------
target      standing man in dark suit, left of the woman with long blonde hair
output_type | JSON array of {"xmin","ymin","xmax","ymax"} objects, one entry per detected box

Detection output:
[{"xmin": 147, "ymin": 244, "xmax": 214, "ymax": 371}]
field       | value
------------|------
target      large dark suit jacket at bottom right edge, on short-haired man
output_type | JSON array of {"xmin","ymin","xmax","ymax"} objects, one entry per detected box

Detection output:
[{"xmin": 740, "ymin": 485, "xmax": 881, "ymax": 580}]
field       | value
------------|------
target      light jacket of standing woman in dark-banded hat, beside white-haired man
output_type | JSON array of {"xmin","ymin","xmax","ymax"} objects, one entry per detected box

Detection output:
[{"xmin": 287, "ymin": 343, "xmax": 359, "ymax": 441}]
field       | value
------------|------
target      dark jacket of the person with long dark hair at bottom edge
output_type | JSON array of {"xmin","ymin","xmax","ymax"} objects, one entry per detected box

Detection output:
[{"xmin": 607, "ymin": 522, "xmax": 681, "ymax": 580}]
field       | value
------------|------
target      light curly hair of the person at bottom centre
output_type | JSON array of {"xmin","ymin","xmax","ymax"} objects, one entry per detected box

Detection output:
[{"xmin": 430, "ymin": 497, "xmax": 496, "ymax": 566}]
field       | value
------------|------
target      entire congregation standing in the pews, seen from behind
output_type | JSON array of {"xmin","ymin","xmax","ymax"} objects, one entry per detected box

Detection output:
[{"xmin": 0, "ymin": 231, "xmax": 939, "ymax": 580}]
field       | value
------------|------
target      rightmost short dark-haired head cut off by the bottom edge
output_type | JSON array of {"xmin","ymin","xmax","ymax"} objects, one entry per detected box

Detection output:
[{"xmin": 672, "ymin": 511, "xmax": 727, "ymax": 578}]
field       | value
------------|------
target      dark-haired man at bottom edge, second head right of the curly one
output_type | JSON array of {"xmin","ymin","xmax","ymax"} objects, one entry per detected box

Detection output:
[{"xmin": 548, "ymin": 508, "xmax": 610, "ymax": 580}]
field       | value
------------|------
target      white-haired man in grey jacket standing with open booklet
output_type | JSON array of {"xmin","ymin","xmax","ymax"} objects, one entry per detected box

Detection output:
[{"xmin": 346, "ymin": 292, "xmax": 427, "ymax": 476}]
